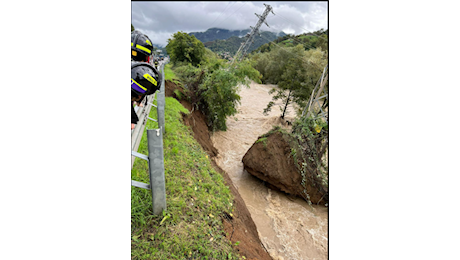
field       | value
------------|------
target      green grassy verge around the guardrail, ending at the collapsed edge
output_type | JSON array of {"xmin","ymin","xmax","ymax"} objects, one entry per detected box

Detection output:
[{"xmin": 131, "ymin": 96, "xmax": 238, "ymax": 259}]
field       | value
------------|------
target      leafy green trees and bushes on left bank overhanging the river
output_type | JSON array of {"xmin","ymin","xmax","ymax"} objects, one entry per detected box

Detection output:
[{"xmin": 166, "ymin": 32, "xmax": 260, "ymax": 131}]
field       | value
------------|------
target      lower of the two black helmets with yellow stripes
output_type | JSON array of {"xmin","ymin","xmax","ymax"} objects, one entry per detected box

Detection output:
[{"xmin": 131, "ymin": 61, "xmax": 161, "ymax": 96}]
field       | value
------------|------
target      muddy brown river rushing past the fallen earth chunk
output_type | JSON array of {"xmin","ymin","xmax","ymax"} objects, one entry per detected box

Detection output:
[{"xmin": 211, "ymin": 82, "xmax": 328, "ymax": 260}]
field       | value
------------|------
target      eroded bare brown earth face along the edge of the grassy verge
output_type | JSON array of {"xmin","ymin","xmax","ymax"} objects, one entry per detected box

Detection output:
[{"xmin": 165, "ymin": 80, "xmax": 272, "ymax": 260}]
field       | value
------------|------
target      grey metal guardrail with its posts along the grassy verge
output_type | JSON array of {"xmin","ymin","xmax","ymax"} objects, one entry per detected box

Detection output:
[{"xmin": 131, "ymin": 60, "xmax": 169, "ymax": 215}]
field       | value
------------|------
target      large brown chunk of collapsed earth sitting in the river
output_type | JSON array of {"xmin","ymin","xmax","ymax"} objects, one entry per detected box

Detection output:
[{"xmin": 242, "ymin": 131, "xmax": 327, "ymax": 205}]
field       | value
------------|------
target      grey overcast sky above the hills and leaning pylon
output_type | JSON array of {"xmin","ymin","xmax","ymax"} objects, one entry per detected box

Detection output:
[{"xmin": 131, "ymin": 1, "xmax": 328, "ymax": 46}]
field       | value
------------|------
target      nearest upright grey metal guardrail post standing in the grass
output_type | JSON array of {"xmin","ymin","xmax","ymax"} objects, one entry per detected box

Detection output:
[{"xmin": 147, "ymin": 128, "xmax": 166, "ymax": 215}]
